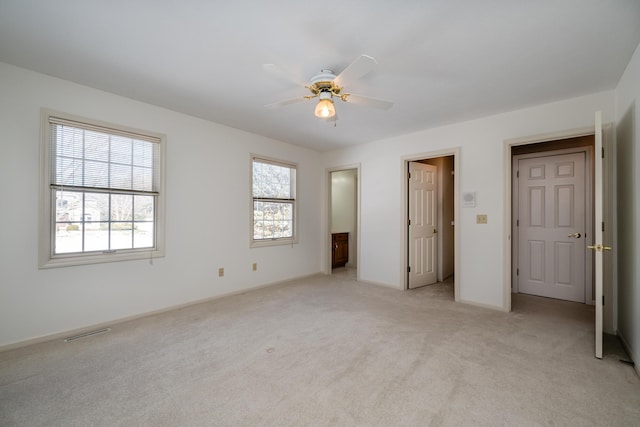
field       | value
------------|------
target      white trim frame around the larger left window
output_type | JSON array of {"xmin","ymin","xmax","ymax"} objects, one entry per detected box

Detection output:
[{"xmin": 38, "ymin": 108, "xmax": 166, "ymax": 269}]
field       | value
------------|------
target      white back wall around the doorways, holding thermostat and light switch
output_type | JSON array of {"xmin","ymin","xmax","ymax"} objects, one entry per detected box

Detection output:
[{"xmin": 323, "ymin": 92, "xmax": 613, "ymax": 309}]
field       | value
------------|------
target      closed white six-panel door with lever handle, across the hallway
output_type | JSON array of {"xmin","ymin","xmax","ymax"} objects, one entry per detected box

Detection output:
[{"xmin": 518, "ymin": 152, "xmax": 586, "ymax": 303}]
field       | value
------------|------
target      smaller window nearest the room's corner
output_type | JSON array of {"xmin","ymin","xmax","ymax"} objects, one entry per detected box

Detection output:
[{"xmin": 251, "ymin": 156, "xmax": 297, "ymax": 246}]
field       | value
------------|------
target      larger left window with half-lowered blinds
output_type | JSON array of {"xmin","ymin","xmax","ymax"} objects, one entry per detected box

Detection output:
[{"xmin": 40, "ymin": 111, "xmax": 164, "ymax": 267}]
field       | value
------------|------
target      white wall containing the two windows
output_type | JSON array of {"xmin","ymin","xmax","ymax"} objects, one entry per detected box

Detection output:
[{"xmin": 0, "ymin": 63, "xmax": 323, "ymax": 352}]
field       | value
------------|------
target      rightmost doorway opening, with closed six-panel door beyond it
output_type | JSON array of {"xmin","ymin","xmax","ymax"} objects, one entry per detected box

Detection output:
[{"xmin": 511, "ymin": 134, "xmax": 595, "ymax": 305}]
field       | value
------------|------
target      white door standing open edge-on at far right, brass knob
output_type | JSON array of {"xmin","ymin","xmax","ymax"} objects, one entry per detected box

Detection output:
[{"xmin": 588, "ymin": 111, "xmax": 611, "ymax": 359}]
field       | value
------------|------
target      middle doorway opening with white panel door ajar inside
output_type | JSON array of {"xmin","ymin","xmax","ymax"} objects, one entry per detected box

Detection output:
[{"xmin": 403, "ymin": 149, "xmax": 460, "ymax": 301}]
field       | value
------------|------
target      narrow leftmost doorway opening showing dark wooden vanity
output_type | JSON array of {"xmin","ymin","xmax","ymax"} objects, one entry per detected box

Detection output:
[{"xmin": 327, "ymin": 166, "xmax": 360, "ymax": 280}]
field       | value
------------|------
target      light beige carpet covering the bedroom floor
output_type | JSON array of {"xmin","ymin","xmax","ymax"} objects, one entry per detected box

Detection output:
[{"xmin": 0, "ymin": 269, "xmax": 640, "ymax": 426}]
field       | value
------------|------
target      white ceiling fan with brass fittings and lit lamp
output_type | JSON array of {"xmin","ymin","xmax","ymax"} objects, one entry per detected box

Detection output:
[{"xmin": 264, "ymin": 55, "xmax": 393, "ymax": 120}]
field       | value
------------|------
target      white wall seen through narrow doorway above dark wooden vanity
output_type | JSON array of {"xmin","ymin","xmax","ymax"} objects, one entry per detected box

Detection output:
[{"xmin": 331, "ymin": 169, "xmax": 358, "ymax": 267}]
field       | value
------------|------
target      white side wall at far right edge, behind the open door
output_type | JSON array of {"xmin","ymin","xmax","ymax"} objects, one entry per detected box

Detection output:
[{"xmin": 613, "ymin": 41, "xmax": 640, "ymax": 374}]
